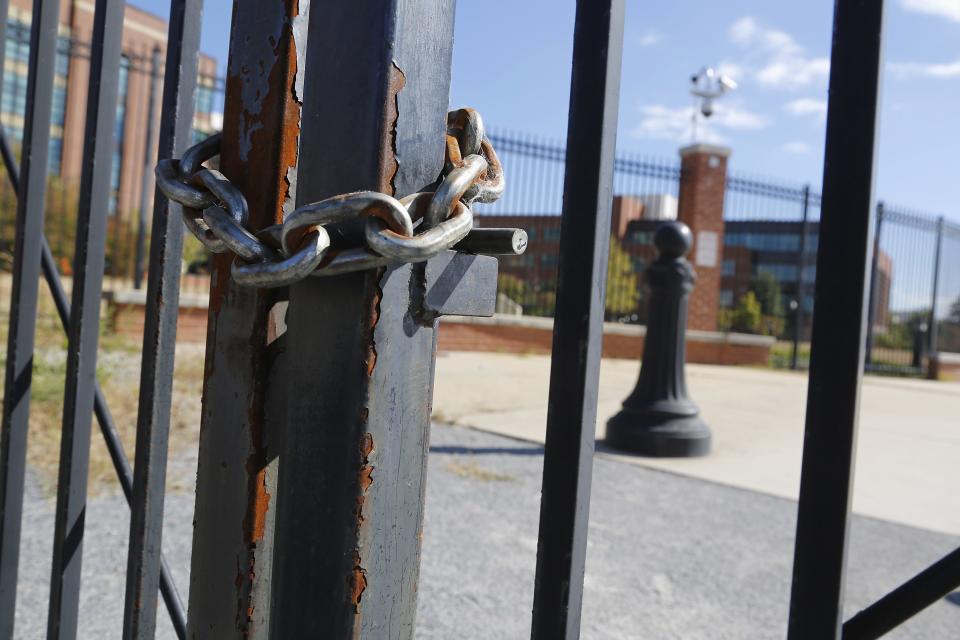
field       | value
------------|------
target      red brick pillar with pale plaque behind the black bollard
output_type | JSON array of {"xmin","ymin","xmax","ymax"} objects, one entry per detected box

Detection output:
[{"xmin": 677, "ymin": 144, "xmax": 730, "ymax": 331}]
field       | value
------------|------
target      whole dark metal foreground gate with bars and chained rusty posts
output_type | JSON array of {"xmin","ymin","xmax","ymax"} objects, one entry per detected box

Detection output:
[{"xmin": 0, "ymin": 0, "xmax": 960, "ymax": 640}]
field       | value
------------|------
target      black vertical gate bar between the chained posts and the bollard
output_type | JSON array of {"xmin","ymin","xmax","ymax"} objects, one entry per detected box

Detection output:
[{"xmin": 531, "ymin": 0, "xmax": 624, "ymax": 640}]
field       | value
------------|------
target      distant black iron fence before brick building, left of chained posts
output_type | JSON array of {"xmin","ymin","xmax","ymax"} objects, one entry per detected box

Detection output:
[{"xmin": 0, "ymin": 16, "xmax": 224, "ymax": 300}]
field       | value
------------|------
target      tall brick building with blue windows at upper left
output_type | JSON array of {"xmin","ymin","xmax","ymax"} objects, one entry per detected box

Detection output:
[{"xmin": 0, "ymin": 0, "xmax": 222, "ymax": 216}]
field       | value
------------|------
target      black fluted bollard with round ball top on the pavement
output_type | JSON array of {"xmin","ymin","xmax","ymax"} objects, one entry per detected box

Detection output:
[{"xmin": 606, "ymin": 222, "xmax": 710, "ymax": 458}]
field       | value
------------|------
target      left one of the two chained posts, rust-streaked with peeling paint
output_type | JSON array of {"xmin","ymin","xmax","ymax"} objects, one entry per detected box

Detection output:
[{"xmin": 188, "ymin": 0, "xmax": 309, "ymax": 638}]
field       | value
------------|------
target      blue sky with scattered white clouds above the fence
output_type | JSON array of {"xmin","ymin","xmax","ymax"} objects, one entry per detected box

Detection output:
[{"xmin": 134, "ymin": 0, "xmax": 960, "ymax": 222}]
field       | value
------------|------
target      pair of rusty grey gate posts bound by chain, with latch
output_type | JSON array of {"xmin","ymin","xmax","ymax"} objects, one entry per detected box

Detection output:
[{"xmin": 180, "ymin": 0, "xmax": 498, "ymax": 638}]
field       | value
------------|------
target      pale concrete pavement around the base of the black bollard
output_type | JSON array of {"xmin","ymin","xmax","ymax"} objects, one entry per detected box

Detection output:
[{"xmin": 434, "ymin": 353, "xmax": 960, "ymax": 535}]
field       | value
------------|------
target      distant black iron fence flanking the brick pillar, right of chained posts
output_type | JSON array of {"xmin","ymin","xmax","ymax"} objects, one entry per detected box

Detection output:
[{"xmin": 477, "ymin": 131, "xmax": 960, "ymax": 374}]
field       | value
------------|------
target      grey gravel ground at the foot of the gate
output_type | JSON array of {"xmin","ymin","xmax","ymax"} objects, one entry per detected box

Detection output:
[{"xmin": 9, "ymin": 426, "xmax": 960, "ymax": 640}]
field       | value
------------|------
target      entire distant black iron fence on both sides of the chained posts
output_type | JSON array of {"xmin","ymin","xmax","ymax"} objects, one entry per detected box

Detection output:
[{"xmin": 0, "ymin": 13, "xmax": 960, "ymax": 380}]
